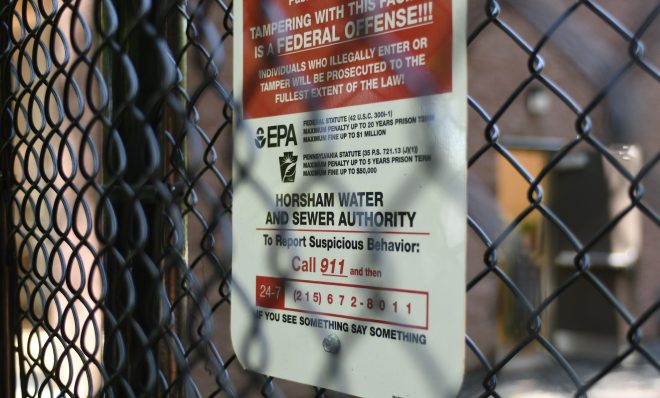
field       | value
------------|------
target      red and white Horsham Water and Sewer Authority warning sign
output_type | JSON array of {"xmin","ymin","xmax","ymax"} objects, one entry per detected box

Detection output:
[{"xmin": 231, "ymin": 0, "xmax": 466, "ymax": 397}]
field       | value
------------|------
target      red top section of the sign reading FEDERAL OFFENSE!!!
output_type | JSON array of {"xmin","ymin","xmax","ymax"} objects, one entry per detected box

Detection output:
[{"xmin": 243, "ymin": 0, "xmax": 452, "ymax": 119}]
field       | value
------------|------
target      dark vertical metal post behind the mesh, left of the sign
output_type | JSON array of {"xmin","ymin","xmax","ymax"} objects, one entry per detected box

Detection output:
[{"xmin": 103, "ymin": 0, "xmax": 158, "ymax": 396}]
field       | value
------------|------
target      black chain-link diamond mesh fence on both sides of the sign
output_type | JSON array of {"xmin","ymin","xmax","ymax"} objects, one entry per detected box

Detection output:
[{"xmin": 0, "ymin": 0, "xmax": 660, "ymax": 397}]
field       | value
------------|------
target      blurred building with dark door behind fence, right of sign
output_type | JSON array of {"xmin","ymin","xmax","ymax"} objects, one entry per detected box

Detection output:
[{"xmin": 468, "ymin": 0, "xmax": 660, "ymax": 388}]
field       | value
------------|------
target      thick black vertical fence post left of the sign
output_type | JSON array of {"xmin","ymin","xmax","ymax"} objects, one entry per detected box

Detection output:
[{"xmin": 103, "ymin": 0, "xmax": 166, "ymax": 395}]
